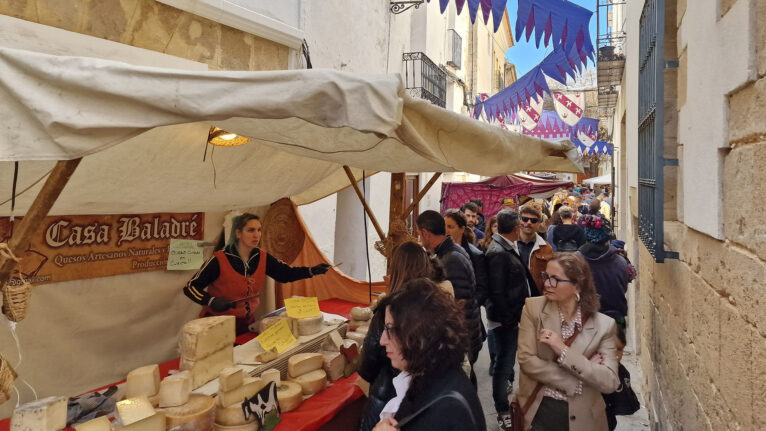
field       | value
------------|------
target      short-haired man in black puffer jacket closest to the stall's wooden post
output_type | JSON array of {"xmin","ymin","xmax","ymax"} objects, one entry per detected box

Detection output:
[{"xmin": 415, "ymin": 210, "xmax": 485, "ymax": 385}]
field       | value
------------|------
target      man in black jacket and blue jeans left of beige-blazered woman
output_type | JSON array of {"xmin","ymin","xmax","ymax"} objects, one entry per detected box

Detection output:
[{"xmin": 486, "ymin": 210, "xmax": 540, "ymax": 431}]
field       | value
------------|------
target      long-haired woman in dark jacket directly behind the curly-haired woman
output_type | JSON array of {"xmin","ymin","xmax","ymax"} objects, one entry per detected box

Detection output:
[{"xmin": 359, "ymin": 241, "xmax": 455, "ymax": 431}]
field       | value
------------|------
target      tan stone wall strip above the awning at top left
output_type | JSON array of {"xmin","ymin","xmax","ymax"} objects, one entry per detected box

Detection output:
[{"xmin": 0, "ymin": 0, "xmax": 289, "ymax": 70}]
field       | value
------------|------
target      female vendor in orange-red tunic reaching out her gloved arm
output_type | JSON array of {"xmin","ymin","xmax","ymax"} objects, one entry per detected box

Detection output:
[{"xmin": 184, "ymin": 213, "xmax": 331, "ymax": 334}]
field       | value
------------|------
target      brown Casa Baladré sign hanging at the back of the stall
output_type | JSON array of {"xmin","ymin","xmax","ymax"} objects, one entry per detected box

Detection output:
[{"xmin": 0, "ymin": 213, "xmax": 205, "ymax": 284}]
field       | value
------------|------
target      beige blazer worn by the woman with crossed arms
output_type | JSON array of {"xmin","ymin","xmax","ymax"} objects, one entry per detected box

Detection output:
[{"xmin": 518, "ymin": 296, "xmax": 619, "ymax": 431}]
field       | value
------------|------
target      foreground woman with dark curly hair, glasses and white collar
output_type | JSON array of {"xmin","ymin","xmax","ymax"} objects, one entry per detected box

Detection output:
[{"xmin": 373, "ymin": 278, "xmax": 486, "ymax": 431}]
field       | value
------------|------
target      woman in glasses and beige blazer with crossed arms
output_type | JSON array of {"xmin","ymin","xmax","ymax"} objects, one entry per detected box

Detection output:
[{"xmin": 518, "ymin": 253, "xmax": 619, "ymax": 431}]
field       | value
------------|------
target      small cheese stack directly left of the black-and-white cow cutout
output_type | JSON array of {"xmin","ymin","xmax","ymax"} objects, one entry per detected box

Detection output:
[{"xmin": 215, "ymin": 367, "xmax": 266, "ymax": 431}]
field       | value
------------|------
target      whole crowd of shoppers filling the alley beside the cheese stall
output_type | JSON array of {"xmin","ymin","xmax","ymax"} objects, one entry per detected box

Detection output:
[{"xmin": 359, "ymin": 189, "xmax": 635, "ymax": 431}]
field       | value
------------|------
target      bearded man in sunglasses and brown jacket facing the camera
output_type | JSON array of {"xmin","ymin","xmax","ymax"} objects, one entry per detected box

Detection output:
[{"xmin": 516, "ymin": 204, "xmax": 553, "ymax": 292}]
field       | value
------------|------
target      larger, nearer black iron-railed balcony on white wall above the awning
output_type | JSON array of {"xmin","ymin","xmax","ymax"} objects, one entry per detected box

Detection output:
[{"xmin": 402, "ymin": 52, "xmax": 447, "ymax": 108}]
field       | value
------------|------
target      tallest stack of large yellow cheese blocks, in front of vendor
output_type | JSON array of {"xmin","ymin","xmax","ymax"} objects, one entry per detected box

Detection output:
[{"xmin": 179, "ymin": 316, "xmax": 236, "ymax": 389}]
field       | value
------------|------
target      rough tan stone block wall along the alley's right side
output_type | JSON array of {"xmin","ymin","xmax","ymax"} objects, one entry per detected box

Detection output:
[{"xmin": 636, "ymin": 0, "xmax": 766, "ymax": 431}]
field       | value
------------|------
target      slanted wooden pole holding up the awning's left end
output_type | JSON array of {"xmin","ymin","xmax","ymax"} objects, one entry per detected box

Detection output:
[{"xmin": 0, "ymin": 159, "xmax": 82, "ymax": 287}]
